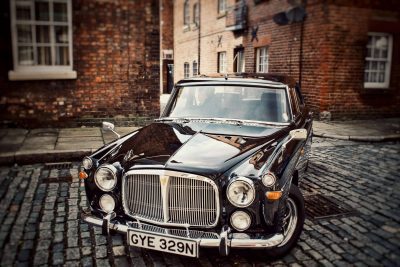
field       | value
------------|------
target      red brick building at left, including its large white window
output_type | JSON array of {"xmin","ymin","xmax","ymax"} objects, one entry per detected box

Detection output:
[{"xmin": 0, "ymin": 0, "xmax": 161, "ymax": 127}]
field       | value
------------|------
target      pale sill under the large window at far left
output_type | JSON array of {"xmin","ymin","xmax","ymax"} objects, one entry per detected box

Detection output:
[{"xmin": 8, "ymin": 70, "xmax": 77, "ymax": 81}]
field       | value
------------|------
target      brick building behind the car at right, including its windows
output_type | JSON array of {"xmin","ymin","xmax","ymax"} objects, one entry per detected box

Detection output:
[{"xmin": 174, "ymin": 0, "xmax": 400, "ymax": 119}]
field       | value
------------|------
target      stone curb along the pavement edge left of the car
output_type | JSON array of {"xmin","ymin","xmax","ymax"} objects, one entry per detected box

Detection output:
[{"xmin": 0, "ymin": 149, "xmax": 95, "ymax": 165}]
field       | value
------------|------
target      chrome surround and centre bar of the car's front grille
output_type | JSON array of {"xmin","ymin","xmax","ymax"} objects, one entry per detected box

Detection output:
[{"xmin": 121, "ymin": 169, "xmax": 220, "ymax": 228}]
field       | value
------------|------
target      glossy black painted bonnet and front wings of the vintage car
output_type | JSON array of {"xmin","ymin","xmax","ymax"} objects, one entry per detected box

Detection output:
[{"xmin": 85, "ymin": 77, "xmax": 311, "ymax": 237}]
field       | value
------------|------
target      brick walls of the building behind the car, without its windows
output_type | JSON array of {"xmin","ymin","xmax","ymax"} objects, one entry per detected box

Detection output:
[{"xmin": 174, "ymin": 0, "xmax": 400, "ymax": 119}]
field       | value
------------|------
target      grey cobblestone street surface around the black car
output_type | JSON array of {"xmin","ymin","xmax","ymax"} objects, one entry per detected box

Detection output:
[{"xmin": 0, "ymin": 138, "xmax": 400, "ymax": 266}]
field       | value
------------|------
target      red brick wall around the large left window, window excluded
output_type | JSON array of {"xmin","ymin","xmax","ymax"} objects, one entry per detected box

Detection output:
[{"xmin": 0, "ymin": 0, "xmax": 159, "ymax": 127}]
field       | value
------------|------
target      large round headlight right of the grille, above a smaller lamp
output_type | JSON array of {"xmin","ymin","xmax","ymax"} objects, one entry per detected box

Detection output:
[{"xmin": 226, "ymin": 177, "xmax": 256, "ymax": 208}]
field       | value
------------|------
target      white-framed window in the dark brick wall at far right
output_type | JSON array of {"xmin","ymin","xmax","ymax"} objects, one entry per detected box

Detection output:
[{"xmin": 364, "ymin": 32, "xmax": 393, "ymax": 88}]
